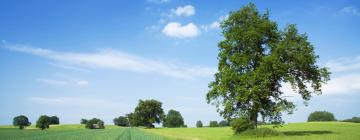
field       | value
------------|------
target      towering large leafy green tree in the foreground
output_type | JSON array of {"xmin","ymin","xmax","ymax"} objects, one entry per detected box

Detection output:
[{"xmin": 207, "ymin": 3, "xmax": 330, "ymax": 128}]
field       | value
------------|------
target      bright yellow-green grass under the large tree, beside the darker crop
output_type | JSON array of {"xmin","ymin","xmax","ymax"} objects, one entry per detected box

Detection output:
[{"xmin": 144, "ymin": 122, "xmax": 360, "ymax": 140}]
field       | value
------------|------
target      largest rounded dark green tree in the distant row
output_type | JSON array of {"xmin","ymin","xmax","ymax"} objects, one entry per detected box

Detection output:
[{"xmin": 134, "ymin": 100, "xmax": 164, "ymax": 128}]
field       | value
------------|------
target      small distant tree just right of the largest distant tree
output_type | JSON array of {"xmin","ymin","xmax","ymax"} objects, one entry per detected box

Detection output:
[{"xmin": 163, "ymin": 109, "xmax": 184, "ymax": 128}]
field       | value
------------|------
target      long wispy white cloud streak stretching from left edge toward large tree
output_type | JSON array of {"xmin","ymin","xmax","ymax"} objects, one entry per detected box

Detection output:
[{"xmin": 5, "ymin": 43, "xmax": 215, "ymax": 79}]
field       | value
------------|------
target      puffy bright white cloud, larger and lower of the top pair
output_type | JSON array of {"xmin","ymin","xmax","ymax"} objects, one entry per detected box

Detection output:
[{"xmin": 162, "ymin": 22, "xmax": 200, "ymax": 38}]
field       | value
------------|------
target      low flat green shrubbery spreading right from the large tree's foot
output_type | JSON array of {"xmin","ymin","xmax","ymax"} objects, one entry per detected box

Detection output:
[{"xmin": 241, "ymin": 128, "xmax": 282, "ymax": 137}]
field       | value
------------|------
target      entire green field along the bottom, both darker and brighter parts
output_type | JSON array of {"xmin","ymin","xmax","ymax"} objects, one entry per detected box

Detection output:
[{"xmin": 0, "ymin": 122, "xmax": 360, "ymax": 140}]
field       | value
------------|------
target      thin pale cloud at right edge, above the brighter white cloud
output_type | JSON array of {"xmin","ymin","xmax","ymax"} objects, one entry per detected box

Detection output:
[{"xmin": 325, "ymin": 56, "xmax": 360, "ymax": 72}]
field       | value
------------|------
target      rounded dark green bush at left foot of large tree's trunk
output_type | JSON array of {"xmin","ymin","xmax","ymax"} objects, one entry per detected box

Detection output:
[{"xmin": 230, "ymin": 118, "xmax": 254, "ymax": 134}]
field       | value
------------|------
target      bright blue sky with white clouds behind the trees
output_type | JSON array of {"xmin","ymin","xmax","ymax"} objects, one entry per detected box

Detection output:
[{"xmin": 0, "ymin": 0, "xmax": 360, "ymax": 126}]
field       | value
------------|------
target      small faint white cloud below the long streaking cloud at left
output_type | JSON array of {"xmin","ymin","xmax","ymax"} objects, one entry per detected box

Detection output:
[{"xmin": 36, "ymin": 78, "xmax": 89, "ymax": 86}]
